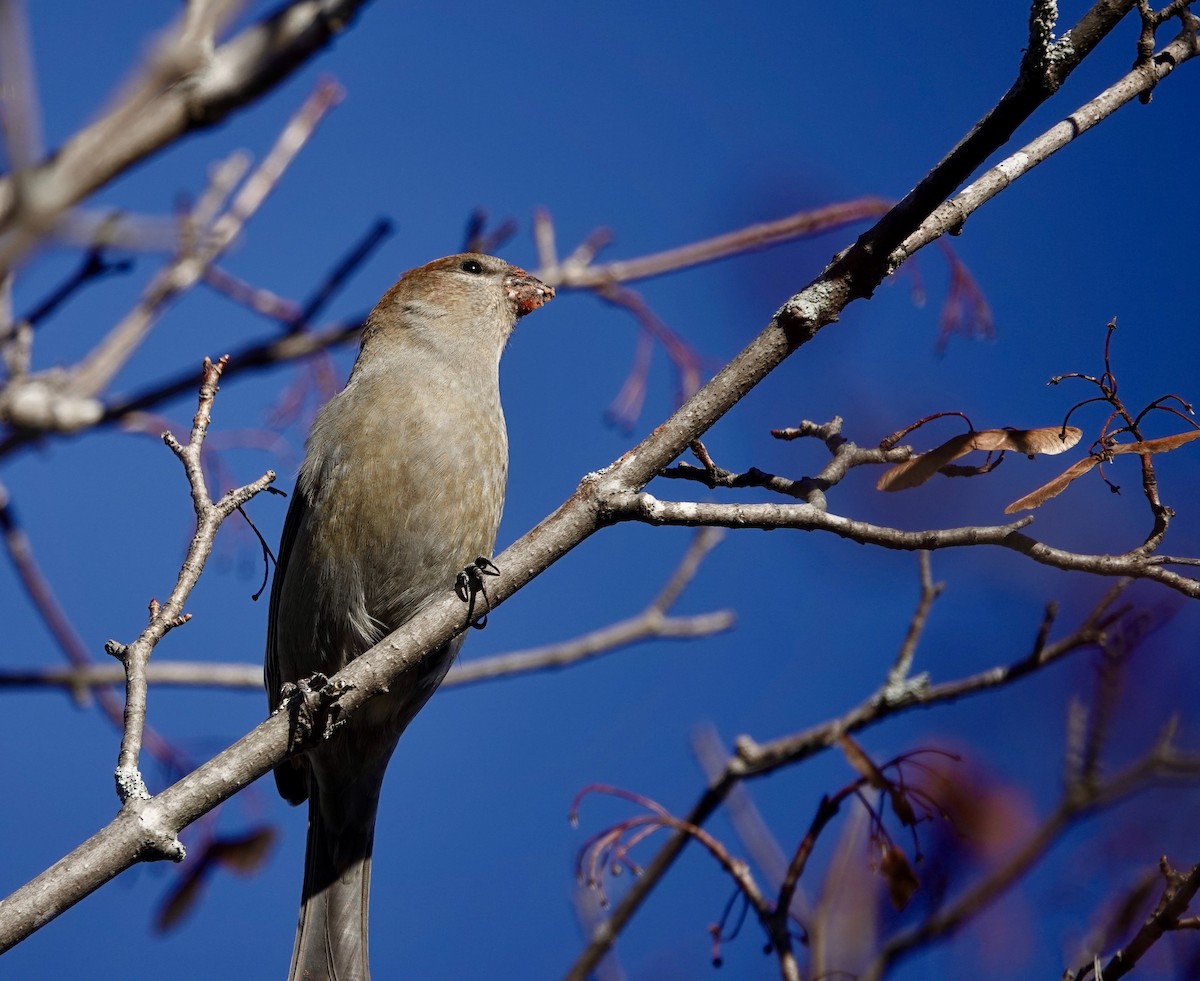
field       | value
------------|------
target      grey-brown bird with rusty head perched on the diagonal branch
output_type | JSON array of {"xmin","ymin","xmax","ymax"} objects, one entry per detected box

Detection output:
[{"xmin": 264, "ymin": 253, "xmax": 554, "ymax": 981}]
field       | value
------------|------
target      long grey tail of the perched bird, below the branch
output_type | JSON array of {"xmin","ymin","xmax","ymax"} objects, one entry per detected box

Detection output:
[{"xmin": 288, "ymin": 768, "xmax": 383, "ymax": 981}]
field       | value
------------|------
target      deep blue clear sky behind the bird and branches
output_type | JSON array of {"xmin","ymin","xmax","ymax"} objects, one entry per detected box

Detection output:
[{"xmin": 0, "ymin": 0, "xmax": 1200, "ymax": 979}]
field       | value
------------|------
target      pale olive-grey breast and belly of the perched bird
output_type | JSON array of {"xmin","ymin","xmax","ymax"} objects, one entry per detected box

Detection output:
[{"xmin": 301, "ymin": 374, "xmax": 508, "ymax": 661}]
